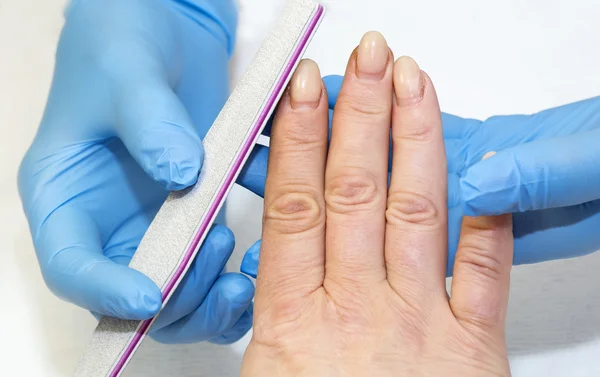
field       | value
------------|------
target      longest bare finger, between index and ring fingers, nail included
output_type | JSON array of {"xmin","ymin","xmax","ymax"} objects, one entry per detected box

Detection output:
[{"xmin": 325, "ymin": 32, "xmax": 393, "ymax": 288}]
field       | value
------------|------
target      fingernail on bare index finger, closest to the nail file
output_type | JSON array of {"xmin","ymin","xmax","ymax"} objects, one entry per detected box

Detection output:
[{"xmin": 290, "ymin": 60, "xmax": 323, "ymax": 109}]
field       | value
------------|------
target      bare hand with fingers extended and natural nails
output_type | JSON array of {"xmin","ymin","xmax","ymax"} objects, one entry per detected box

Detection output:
[{"xmin": 242, "ymin": 33, "xmax": 513, "ymax": 377}]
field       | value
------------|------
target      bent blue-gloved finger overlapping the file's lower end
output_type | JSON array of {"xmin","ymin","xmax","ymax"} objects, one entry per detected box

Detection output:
[{"xmin": 35, "ymin": 207, "xmax": 162, "ymax": 320}]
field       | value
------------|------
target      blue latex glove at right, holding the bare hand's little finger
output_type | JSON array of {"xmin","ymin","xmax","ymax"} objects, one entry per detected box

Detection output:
[{"xmin": 242, "ymin": 76, "xmax": 600, "ymax": 276}]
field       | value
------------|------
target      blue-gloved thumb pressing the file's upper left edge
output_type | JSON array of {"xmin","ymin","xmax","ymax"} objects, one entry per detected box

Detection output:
[{"xmin": 116, "ymin": 79, "xmax": 204, "ymax": 190}]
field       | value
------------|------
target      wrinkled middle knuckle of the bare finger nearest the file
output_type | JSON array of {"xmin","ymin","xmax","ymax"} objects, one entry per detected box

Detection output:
[{"xmin": 263, "ymin": 188, "xmax": 324, "ymax": 234}]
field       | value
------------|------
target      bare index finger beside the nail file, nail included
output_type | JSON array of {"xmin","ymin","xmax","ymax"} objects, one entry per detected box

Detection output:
[{"xmin": 256, "ymin": 60, "xmax": 327, "ymax": 304}]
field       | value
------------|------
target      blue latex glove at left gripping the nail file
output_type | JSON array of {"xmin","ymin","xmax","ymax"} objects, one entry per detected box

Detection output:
[{"xmin": 19, "ymin": 0, "xmax": 266, "ymax": 343}]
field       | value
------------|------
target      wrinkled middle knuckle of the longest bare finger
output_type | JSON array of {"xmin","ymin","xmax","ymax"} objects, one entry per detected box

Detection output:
[{"xmin": 325, "ymin": 172, "xmax": 381, "ymax": 214}]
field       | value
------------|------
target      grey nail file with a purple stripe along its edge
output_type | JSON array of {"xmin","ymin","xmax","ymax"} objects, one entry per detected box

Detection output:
[{"xmin": 75, "ymin": 0, "xmax": 325, "ymax": 377}]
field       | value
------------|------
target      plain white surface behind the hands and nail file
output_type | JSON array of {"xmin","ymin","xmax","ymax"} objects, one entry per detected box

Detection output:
[{"xmin": 0, "ymin": 0, "xmax": 600, "ymax": 377}]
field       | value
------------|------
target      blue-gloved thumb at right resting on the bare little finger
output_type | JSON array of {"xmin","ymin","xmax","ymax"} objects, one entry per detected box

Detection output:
[{"xmin": 460, "ymin": 129, "xmax": 600, "ymax": 216}]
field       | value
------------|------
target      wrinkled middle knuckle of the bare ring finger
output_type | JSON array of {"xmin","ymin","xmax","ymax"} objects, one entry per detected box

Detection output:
[{"xmin": 385, "ymin": 191, "xmax": 441, "ymax": 227}]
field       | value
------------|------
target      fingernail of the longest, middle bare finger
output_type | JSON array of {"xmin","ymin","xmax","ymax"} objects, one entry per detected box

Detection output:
[{"xmin": 356, "ymin": 31, "xmax": 390, "ymax": 80}]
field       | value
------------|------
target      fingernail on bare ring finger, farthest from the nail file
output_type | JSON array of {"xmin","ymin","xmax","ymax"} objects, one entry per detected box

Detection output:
[{"xmin": 394, "ymin": 56, "xmax": 423, "ymax": 106}]
